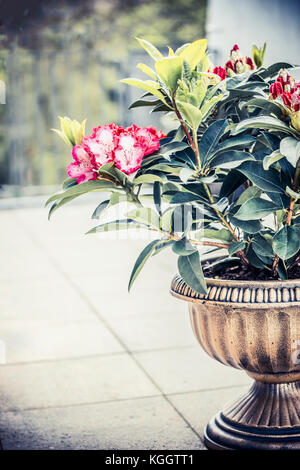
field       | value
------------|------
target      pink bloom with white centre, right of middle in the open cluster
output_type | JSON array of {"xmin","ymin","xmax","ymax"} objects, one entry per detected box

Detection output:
[{"xmin": 114, "ymin": 131, "xmax": 145, "ymax": 174}]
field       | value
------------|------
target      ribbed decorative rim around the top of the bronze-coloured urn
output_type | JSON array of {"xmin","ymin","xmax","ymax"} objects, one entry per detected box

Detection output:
[{"xmin": 170, "ymin": 275, "xmax": 300, "ymax": 308}]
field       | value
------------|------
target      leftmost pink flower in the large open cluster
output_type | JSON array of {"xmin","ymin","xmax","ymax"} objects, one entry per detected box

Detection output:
[{"xmin": 67, "ymin": 145, "xmax": 97, "ymax": 183}]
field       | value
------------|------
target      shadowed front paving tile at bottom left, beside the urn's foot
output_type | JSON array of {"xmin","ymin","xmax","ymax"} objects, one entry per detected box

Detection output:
[{"xmin": 0, "ymin": 397, "xmax": 203, "ymax": 450}]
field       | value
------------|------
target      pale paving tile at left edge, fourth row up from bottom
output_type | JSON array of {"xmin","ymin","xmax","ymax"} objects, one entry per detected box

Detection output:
[{"xmin": 0, "ymin": 278, "xmax": 95, "ymax": 322}]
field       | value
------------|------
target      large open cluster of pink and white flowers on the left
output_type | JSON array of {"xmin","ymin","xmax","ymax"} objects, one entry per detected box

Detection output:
[{"xmin": 67, "ymin": 124, "xmax": 166, "ymax": 183}]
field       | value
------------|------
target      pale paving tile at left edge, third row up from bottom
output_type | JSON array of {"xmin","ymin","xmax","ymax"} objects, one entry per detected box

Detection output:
[{"xmin": 0, "ymin": 320, "xmax": 124, "ymax": 364}]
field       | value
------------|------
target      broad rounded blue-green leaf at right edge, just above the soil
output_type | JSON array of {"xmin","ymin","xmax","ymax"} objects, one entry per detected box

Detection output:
[{"xmin": 272, "ymin": 225, "xmax": 300, "ymax": 260}]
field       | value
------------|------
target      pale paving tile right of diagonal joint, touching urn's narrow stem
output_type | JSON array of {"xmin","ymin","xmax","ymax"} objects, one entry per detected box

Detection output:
[{"xmin": 135, "ymin": 346, "xmax": 251, "ymax": 394}]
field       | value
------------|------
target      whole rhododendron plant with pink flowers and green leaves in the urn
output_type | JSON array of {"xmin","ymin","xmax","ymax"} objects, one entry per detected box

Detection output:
[{"xmin": 48, "ymin": 39, "xmax": 300, "ymax": 293}]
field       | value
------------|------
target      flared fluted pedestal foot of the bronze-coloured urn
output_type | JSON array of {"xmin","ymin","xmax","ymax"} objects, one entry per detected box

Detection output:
[{"xmin": 204, "ymin": 377, "xmax": 300, "ymax": 450}]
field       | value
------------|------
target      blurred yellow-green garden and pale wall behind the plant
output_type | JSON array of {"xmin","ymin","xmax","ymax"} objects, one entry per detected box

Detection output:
[{"xmin": 0, "ymin": 0, "xmax": 300, "ymax": 197}]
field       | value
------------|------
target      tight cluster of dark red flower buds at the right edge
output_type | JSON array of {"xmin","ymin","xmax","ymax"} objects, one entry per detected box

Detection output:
[{"xmin": 269, "ymin": 69, "xmax": 300, "ymax": 131}]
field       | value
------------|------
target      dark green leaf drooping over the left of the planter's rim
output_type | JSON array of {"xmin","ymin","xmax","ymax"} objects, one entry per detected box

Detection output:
[{"xmin": 178, "ymin": 251, "xmax": 207, "ymax": 294}]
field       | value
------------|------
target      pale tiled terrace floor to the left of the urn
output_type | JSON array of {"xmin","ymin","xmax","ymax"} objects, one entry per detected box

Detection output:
[{"xmin": 0, "ymin": 196, "xmax": 250, "ymax": 450}]
